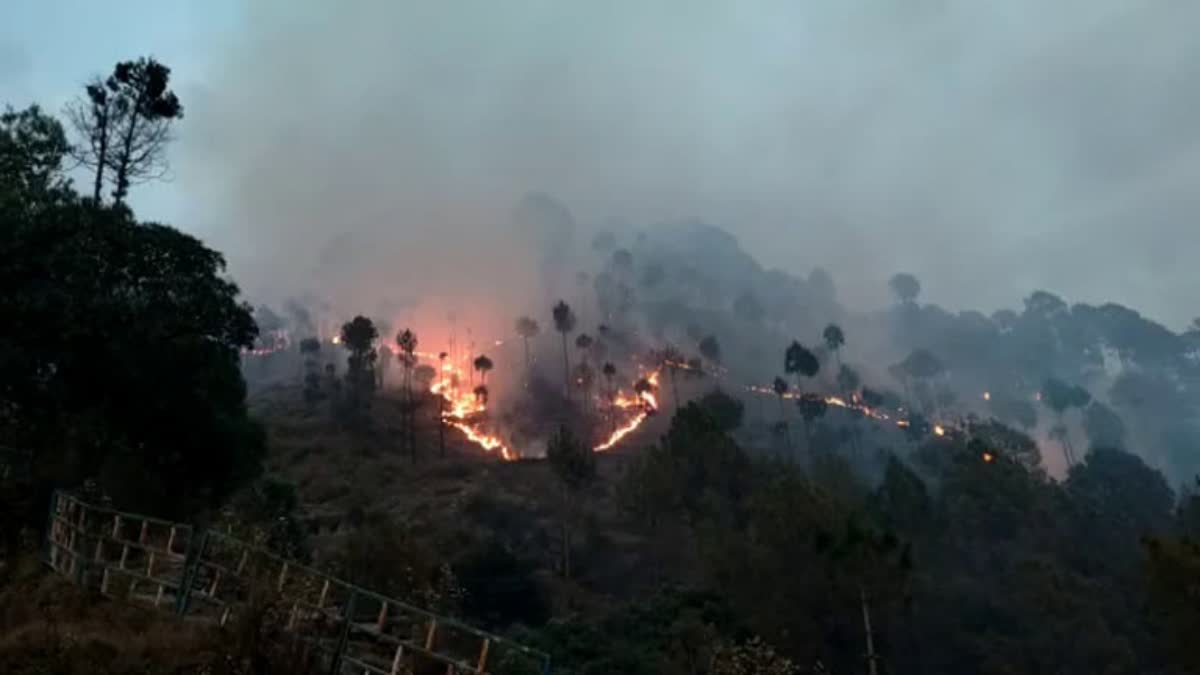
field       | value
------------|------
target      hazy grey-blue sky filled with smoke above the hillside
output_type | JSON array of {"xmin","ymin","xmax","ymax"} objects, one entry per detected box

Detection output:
[{"xmin": 7, "ymin": 0, "xmax": 1200, "ymax": 328}]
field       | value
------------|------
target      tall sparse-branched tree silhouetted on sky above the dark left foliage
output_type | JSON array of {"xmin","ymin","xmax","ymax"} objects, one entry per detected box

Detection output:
[{"xmin": 68, "ymin": 58, "xmax": 184, "ymax": 203}]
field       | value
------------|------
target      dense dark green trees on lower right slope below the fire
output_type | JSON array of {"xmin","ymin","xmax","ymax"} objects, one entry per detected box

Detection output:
[{"xmin": 538, "ymin": 405, "xmax": 1200, "ymax": 675}]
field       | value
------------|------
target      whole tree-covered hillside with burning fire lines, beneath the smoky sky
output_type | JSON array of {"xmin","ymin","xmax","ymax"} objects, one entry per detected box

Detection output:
[{"xmin": 0, "ymin": 59, "xmax": 1200, "ymax": 675}]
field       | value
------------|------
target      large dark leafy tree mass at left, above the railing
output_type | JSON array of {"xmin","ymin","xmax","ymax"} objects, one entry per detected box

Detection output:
[{"xmin": 0, "ymin": 102, "xmax": 263, "ymax": 513}]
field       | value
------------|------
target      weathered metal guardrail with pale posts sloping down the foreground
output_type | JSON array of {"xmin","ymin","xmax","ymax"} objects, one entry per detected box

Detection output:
[{"xmin": 46, "ymin": 491, "xmax": 550, "ymax": 675}]
